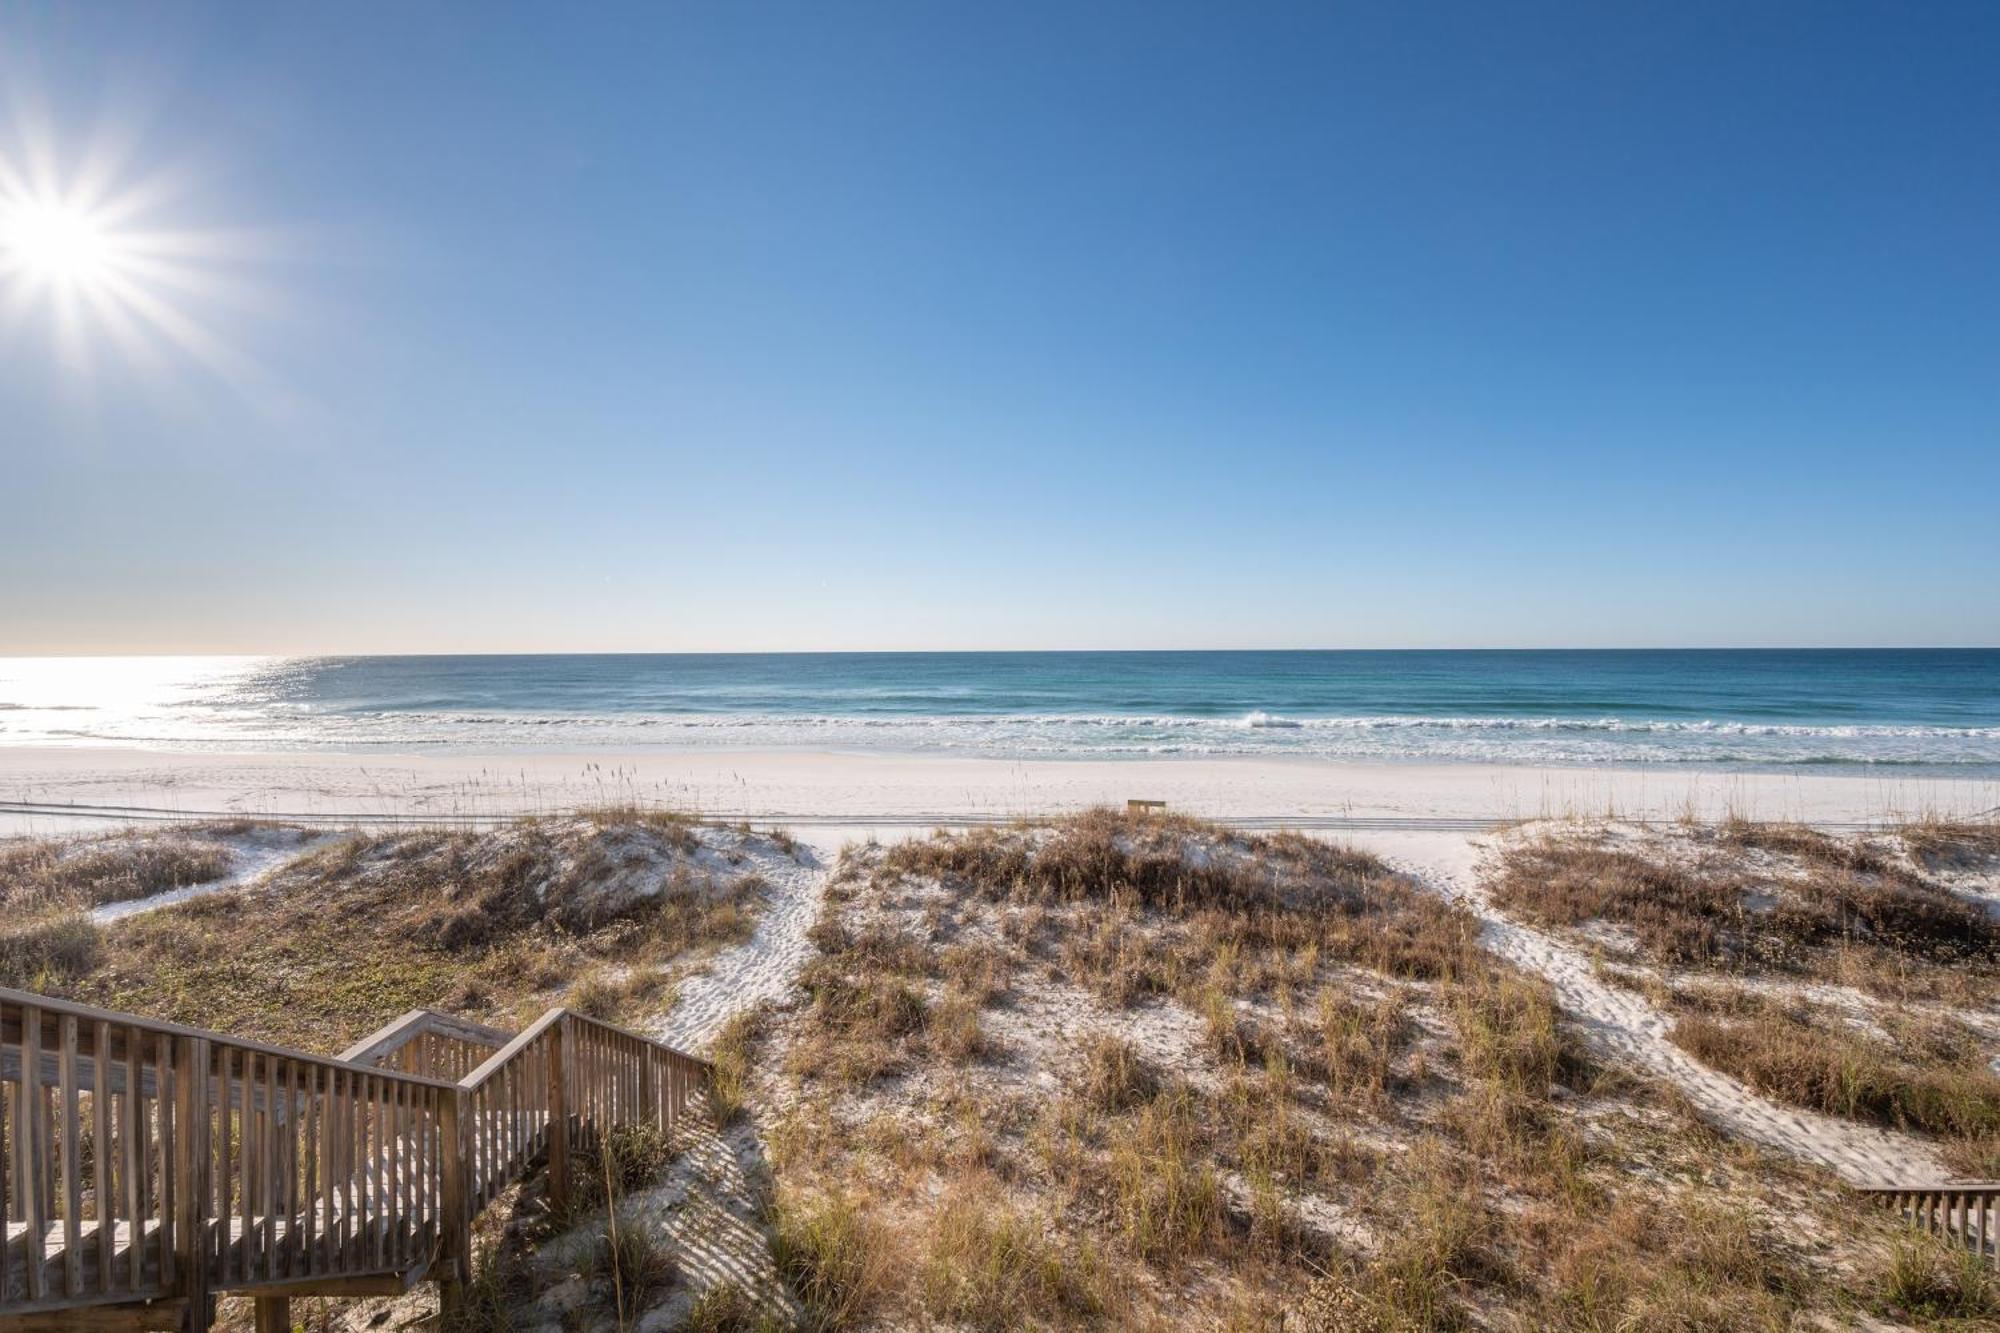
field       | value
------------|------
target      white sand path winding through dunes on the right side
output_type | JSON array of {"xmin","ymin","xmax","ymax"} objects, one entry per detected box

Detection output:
[{"xmin": 1384, "ymin": 839, "xmax": 1952, "ymax": 1185}]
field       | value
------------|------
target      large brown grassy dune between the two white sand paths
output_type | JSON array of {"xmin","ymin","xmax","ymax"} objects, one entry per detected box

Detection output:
[{"xmin": 766, "ymin": 813, "xmax": 1884, "ymax": 1329}]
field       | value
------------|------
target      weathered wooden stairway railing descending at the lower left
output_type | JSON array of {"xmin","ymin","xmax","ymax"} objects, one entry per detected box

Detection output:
[{"xmin": 0, "ymin": 989, "xmax": 708, "ymax": 1333}]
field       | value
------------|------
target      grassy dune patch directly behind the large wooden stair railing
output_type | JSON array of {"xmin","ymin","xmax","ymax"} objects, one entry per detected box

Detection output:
[{"xmin": 44, "ymin": 821, "xmax": 762, "ymax": 1051}]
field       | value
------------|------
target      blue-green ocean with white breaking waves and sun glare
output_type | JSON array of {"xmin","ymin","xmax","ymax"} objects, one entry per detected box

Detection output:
[{"xmin": 0, "ymin": 648, "xmax": 2000, "ymax": 777}]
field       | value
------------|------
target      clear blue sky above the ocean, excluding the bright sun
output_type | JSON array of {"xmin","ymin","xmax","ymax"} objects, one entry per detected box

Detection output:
[{"xmin": 0, "ymin": 0, "xmax": 2000, "ymax": 652}]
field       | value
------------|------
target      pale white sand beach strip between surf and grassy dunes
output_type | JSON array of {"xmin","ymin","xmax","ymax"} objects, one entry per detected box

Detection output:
[{"xmin": 0, "ymin": 747, "xmax": 2000, "ymax": 833}]
